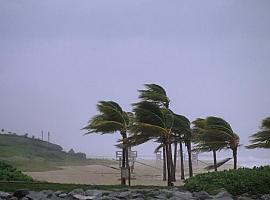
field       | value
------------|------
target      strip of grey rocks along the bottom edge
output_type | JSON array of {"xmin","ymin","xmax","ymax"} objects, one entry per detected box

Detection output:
[{"xmin": 0, "ymin": 188, "xmax": 270, "ymax": 200}]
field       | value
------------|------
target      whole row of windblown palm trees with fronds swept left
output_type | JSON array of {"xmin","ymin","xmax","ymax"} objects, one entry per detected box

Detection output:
[{"xmin": 83, "ymin": 84, "xmax": 269, "ymax": 186}]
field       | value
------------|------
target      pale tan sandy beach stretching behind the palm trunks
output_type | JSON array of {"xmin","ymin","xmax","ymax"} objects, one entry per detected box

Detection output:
[{"xmin": 26, "ymin": 160, "xmax": 232, "ymax": 186}]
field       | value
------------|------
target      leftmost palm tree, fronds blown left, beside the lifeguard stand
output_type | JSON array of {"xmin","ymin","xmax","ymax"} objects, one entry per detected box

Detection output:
[{"xmin": 83, "ymin": 101, "xmax": 129, "ymax": 185}]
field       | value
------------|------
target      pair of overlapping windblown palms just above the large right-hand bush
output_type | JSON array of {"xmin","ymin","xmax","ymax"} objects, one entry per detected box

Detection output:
[{"xmin": 193, "ymin": 116, "xmax": 239, "ymax": 170}]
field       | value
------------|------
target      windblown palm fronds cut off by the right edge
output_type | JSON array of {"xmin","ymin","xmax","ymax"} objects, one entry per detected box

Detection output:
[{"xmin": 247, "ymin": 117, "xmax": 270, "ymax": 149}]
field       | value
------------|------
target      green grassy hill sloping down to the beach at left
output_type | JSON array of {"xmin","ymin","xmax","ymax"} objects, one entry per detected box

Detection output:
[{"xmin": 0, "ymin": 134, "xmax": 114, "ymax": 171}]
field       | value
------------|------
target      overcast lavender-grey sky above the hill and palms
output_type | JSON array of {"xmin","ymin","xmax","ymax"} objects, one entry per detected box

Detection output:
[{"xmin": 0, "ymin": 0, "xmax": 270, "ymax": 159}]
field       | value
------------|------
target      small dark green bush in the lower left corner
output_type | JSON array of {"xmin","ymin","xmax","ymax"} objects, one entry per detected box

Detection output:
[{"xmin": 0, "ymin": 161, "xmax": 33, "ymax": 181}]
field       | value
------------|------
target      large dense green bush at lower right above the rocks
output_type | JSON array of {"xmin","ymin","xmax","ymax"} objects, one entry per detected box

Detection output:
[{"xmin": 184, "ymin": 166, "xmax": 270, "ymax": 195}]
